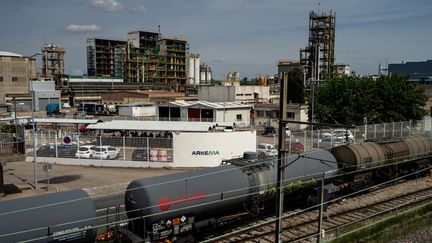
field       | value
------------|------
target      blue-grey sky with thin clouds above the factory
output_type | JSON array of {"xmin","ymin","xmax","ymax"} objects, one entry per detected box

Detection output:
[{"xmin": 0, "ymin": 0, "xmax": 432, "ymax": 79}]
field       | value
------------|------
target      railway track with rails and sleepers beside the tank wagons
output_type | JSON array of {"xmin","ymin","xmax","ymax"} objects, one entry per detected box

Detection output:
[{"xmin": 208, "ymin": 177, "xmax": 432, "ymax": 243}]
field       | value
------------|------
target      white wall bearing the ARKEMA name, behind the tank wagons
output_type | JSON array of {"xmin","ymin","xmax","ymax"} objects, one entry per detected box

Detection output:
[{"xmin": 172, "ymin": 131, "xmax": 256, "ymax": 167}]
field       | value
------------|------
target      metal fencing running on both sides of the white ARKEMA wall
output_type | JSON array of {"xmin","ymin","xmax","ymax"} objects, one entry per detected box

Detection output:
[{"xmin": 25, "ymin": 120, "xmax": 425, "ymax": 162}]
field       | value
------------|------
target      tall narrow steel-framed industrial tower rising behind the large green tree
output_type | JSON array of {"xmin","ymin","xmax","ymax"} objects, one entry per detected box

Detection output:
[{"xmin": 300, "ymin": 11, "xmax": 336, "ymax": 80}]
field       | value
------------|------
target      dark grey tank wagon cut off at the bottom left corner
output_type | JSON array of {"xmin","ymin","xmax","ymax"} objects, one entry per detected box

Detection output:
[{"xmin": 0, "ymin": 190, "xmax": 96, "ymax": 243}]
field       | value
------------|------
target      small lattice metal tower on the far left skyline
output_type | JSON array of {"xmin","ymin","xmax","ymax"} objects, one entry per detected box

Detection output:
[{"xmin": 42, "ymin": 43, "xmax": 66, "ymax": 87}]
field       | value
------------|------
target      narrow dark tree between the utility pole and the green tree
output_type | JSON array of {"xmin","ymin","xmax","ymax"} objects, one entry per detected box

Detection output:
[{"xmin": 288, "ymin": 68, "xmax": 305, "ymax": 104}]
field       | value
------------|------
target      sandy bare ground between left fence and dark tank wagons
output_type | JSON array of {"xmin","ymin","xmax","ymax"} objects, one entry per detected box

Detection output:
[{"xmin": 0, "ymin": 162, "xmax": 192, "ymax": 200}]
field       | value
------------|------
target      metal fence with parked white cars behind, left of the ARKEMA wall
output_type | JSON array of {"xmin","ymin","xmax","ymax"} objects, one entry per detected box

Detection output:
[{"xmin": 25, "ymin": 131, "xmax": 173, "ymax": 162}]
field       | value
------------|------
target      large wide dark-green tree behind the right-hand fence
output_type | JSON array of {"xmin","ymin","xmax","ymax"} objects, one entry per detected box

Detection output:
[{"xmin": 308, "ymin": 75, "xmax": 427, "ymax": 125}]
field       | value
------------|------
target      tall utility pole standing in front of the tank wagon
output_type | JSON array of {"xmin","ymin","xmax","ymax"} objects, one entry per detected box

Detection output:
[{"xmin": 275, "ymin": 73, "xmax": 288, "ymax": 243}]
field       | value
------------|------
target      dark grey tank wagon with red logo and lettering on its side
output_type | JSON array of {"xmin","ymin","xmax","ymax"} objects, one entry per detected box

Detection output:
[{"xmin": 125, "ymin": 150, "xmax": 337, "ymax": 240}]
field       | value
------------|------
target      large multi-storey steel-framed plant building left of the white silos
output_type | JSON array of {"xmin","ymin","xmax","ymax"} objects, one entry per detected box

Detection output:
[{"xmin": 87, "ymin": 31, "xmax": 189, "ymax": 91}]
